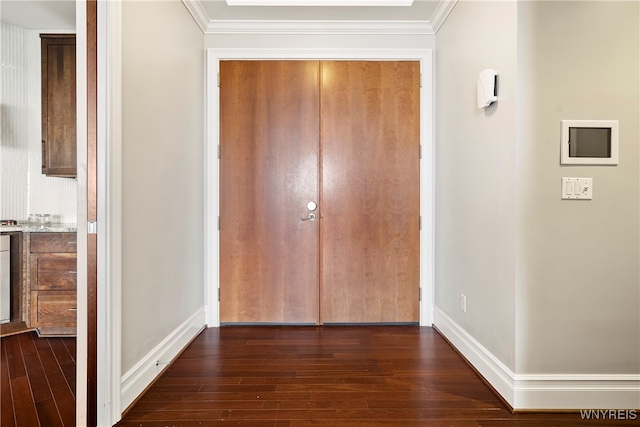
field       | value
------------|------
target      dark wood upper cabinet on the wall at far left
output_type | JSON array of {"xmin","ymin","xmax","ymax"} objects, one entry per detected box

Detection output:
[{"xmin": 40, "ymin": 34, "xmax": 76, "ymax": 177}]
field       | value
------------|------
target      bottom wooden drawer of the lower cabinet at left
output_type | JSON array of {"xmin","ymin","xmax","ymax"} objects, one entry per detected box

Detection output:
[{"xmin": 31, "ymin": 292, "xmax": 77, "ymax": 327}]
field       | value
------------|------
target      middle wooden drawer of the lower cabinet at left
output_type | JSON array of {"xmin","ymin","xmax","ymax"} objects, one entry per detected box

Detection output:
[{"xmin": 30, "ymin": 253, "xmax": 78, "ymax": 291}]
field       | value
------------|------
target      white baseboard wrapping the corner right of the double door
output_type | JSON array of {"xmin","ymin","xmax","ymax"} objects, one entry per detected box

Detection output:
[{"xmin": 433, "ymin": 307, "xmax": 640, "ymax": 410}]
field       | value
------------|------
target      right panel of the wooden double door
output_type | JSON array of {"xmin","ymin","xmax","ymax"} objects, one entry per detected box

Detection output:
[{"xmin": 320, "ymin": 61, "xmax": 420, "ymax": 323}]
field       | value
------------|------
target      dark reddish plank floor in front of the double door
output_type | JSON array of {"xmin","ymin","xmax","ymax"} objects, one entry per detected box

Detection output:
[{"xmin": 118, "ymin": 326, "xmax": 620, "ymax": 427}]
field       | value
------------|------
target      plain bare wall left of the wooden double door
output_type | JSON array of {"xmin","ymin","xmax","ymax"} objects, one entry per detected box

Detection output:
[{"xmin": 121, "ymin": 0, "xmax": 205, "ymax": 378}]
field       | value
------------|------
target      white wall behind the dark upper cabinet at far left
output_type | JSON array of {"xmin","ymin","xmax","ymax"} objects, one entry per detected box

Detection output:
[{"xmin": 0, "ymin": 23, "xmax": 77, "ymax": 223}]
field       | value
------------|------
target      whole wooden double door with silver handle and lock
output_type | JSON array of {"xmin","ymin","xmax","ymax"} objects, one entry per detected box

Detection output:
[{"xmin": 220, "ymin": 61, "xmax": 420, "ymax": 324}]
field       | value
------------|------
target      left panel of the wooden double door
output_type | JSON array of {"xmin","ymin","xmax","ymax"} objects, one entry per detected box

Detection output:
[{"xmin": 220, "ymin": 61, "xmax": 319, "ymax": 324}]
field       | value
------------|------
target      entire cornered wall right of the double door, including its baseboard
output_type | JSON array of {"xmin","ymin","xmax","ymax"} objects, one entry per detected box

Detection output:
[{"xmin": 434, "ymin": 1, "xmax": 640, "ymax": 409}]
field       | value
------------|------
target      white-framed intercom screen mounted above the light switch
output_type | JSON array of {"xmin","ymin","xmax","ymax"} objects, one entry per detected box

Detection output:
[{"xmin": 560, "ymin": 120, "xmax": 618, "ymax": 165}]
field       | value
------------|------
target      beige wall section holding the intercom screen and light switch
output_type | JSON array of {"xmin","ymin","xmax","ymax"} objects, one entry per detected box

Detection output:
[{"xmin": 516, "ymin": 1, "xmax": 640, "ymax": 375}]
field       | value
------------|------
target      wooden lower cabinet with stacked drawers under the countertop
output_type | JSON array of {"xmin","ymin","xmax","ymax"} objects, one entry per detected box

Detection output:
[{"xmin": 29, "ymin": 233, "xmax": 77, "ymax": 335}]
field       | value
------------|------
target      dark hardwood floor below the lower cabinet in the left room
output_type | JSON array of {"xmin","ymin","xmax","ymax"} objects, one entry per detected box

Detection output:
[{"xmin": 0, "ymin": 331, "xmax": 76, "ymax": 427}]
